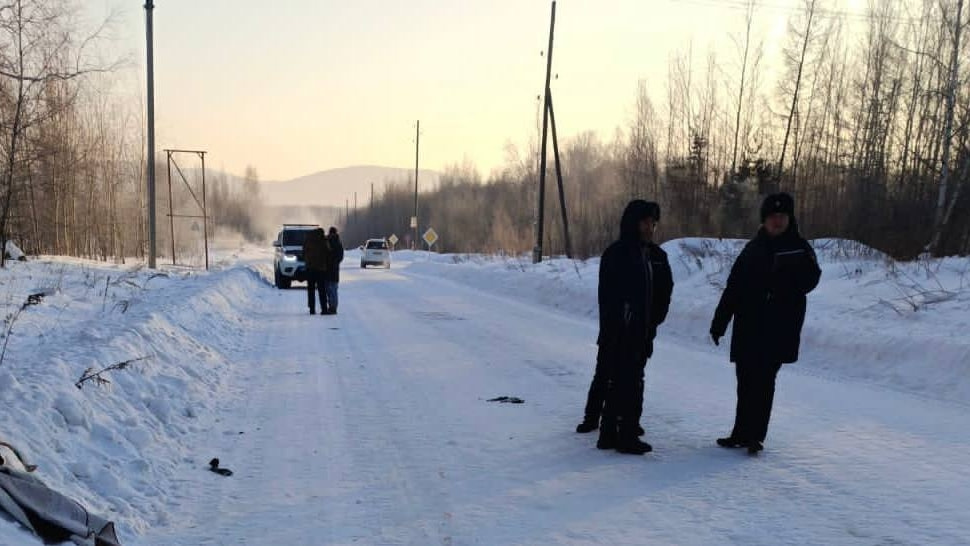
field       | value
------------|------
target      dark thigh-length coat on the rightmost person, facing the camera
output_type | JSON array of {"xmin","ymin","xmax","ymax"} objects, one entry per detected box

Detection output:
[{"xmin": 711, "ymin": 219, "xmax": 822, "ymax": 364}]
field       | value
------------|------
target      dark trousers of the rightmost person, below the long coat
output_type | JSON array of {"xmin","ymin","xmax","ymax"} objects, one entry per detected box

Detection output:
[{"xmin": 731, "ymin": 362, "xmax": 781, "ymax": 442}]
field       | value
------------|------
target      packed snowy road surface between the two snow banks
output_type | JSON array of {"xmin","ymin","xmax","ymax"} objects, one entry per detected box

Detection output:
[{"xmin": 144, "ymin": 258, "xmax": 970, "ymax": 545}]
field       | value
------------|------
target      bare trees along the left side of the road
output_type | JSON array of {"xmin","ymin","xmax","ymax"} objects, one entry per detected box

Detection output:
[{"xmin": 0, "ymin": 0, "xmax": 262, "ymax": 261}]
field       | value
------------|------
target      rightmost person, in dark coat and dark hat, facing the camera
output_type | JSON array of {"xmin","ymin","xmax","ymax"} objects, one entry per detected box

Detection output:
[{"xmin": 711, "ymin": 193, "xmax": 822, "ymax": 454}]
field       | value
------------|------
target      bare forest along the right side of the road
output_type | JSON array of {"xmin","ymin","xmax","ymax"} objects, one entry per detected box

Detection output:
[{"xmin": 345, "ymin": 0, "xmax": 970, "ymax": 259}]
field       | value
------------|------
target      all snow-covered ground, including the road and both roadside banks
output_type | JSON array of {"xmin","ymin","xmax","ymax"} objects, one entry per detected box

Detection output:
[{"xmin": 0, "ymin": 240, "xmax": 970, "ymax": 545}]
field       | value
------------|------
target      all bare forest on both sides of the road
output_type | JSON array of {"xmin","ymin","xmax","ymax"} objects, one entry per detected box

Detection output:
[{"xmin": 0, "ymin": 0, "xmax": 970, "ymax": 260}]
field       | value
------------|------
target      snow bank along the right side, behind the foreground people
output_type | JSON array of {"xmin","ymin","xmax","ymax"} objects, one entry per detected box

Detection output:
[{"xmin": 394, "ymin": 239, "xmax": 970, "ymax": 402}]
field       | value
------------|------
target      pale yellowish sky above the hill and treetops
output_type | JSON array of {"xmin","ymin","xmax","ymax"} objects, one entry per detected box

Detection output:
[{"xmin": 86, "ymin": 0, "xmax": 859, "ymax": 180}]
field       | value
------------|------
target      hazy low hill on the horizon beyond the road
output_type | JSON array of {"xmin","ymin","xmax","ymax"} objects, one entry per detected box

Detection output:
[{"xmin": 259, "ymin": 165, "xmax": 441, "ymax": 207}]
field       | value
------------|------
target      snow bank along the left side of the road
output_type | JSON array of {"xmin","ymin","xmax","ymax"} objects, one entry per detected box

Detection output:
[{"xmin": 0, "ymin": 260, "xmax": 264, "ymax": 544}]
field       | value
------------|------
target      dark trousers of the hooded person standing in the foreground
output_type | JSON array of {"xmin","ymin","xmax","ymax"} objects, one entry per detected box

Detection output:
[{"xmin": 600, "ymin": 347, "xmax": 647, "ymax": 438}]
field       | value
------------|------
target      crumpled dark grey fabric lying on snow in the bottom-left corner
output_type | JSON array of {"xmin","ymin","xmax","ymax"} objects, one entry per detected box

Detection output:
[{"xmin": 0, "ymin": 452, "xmax": 120, "ymax": 546}]
